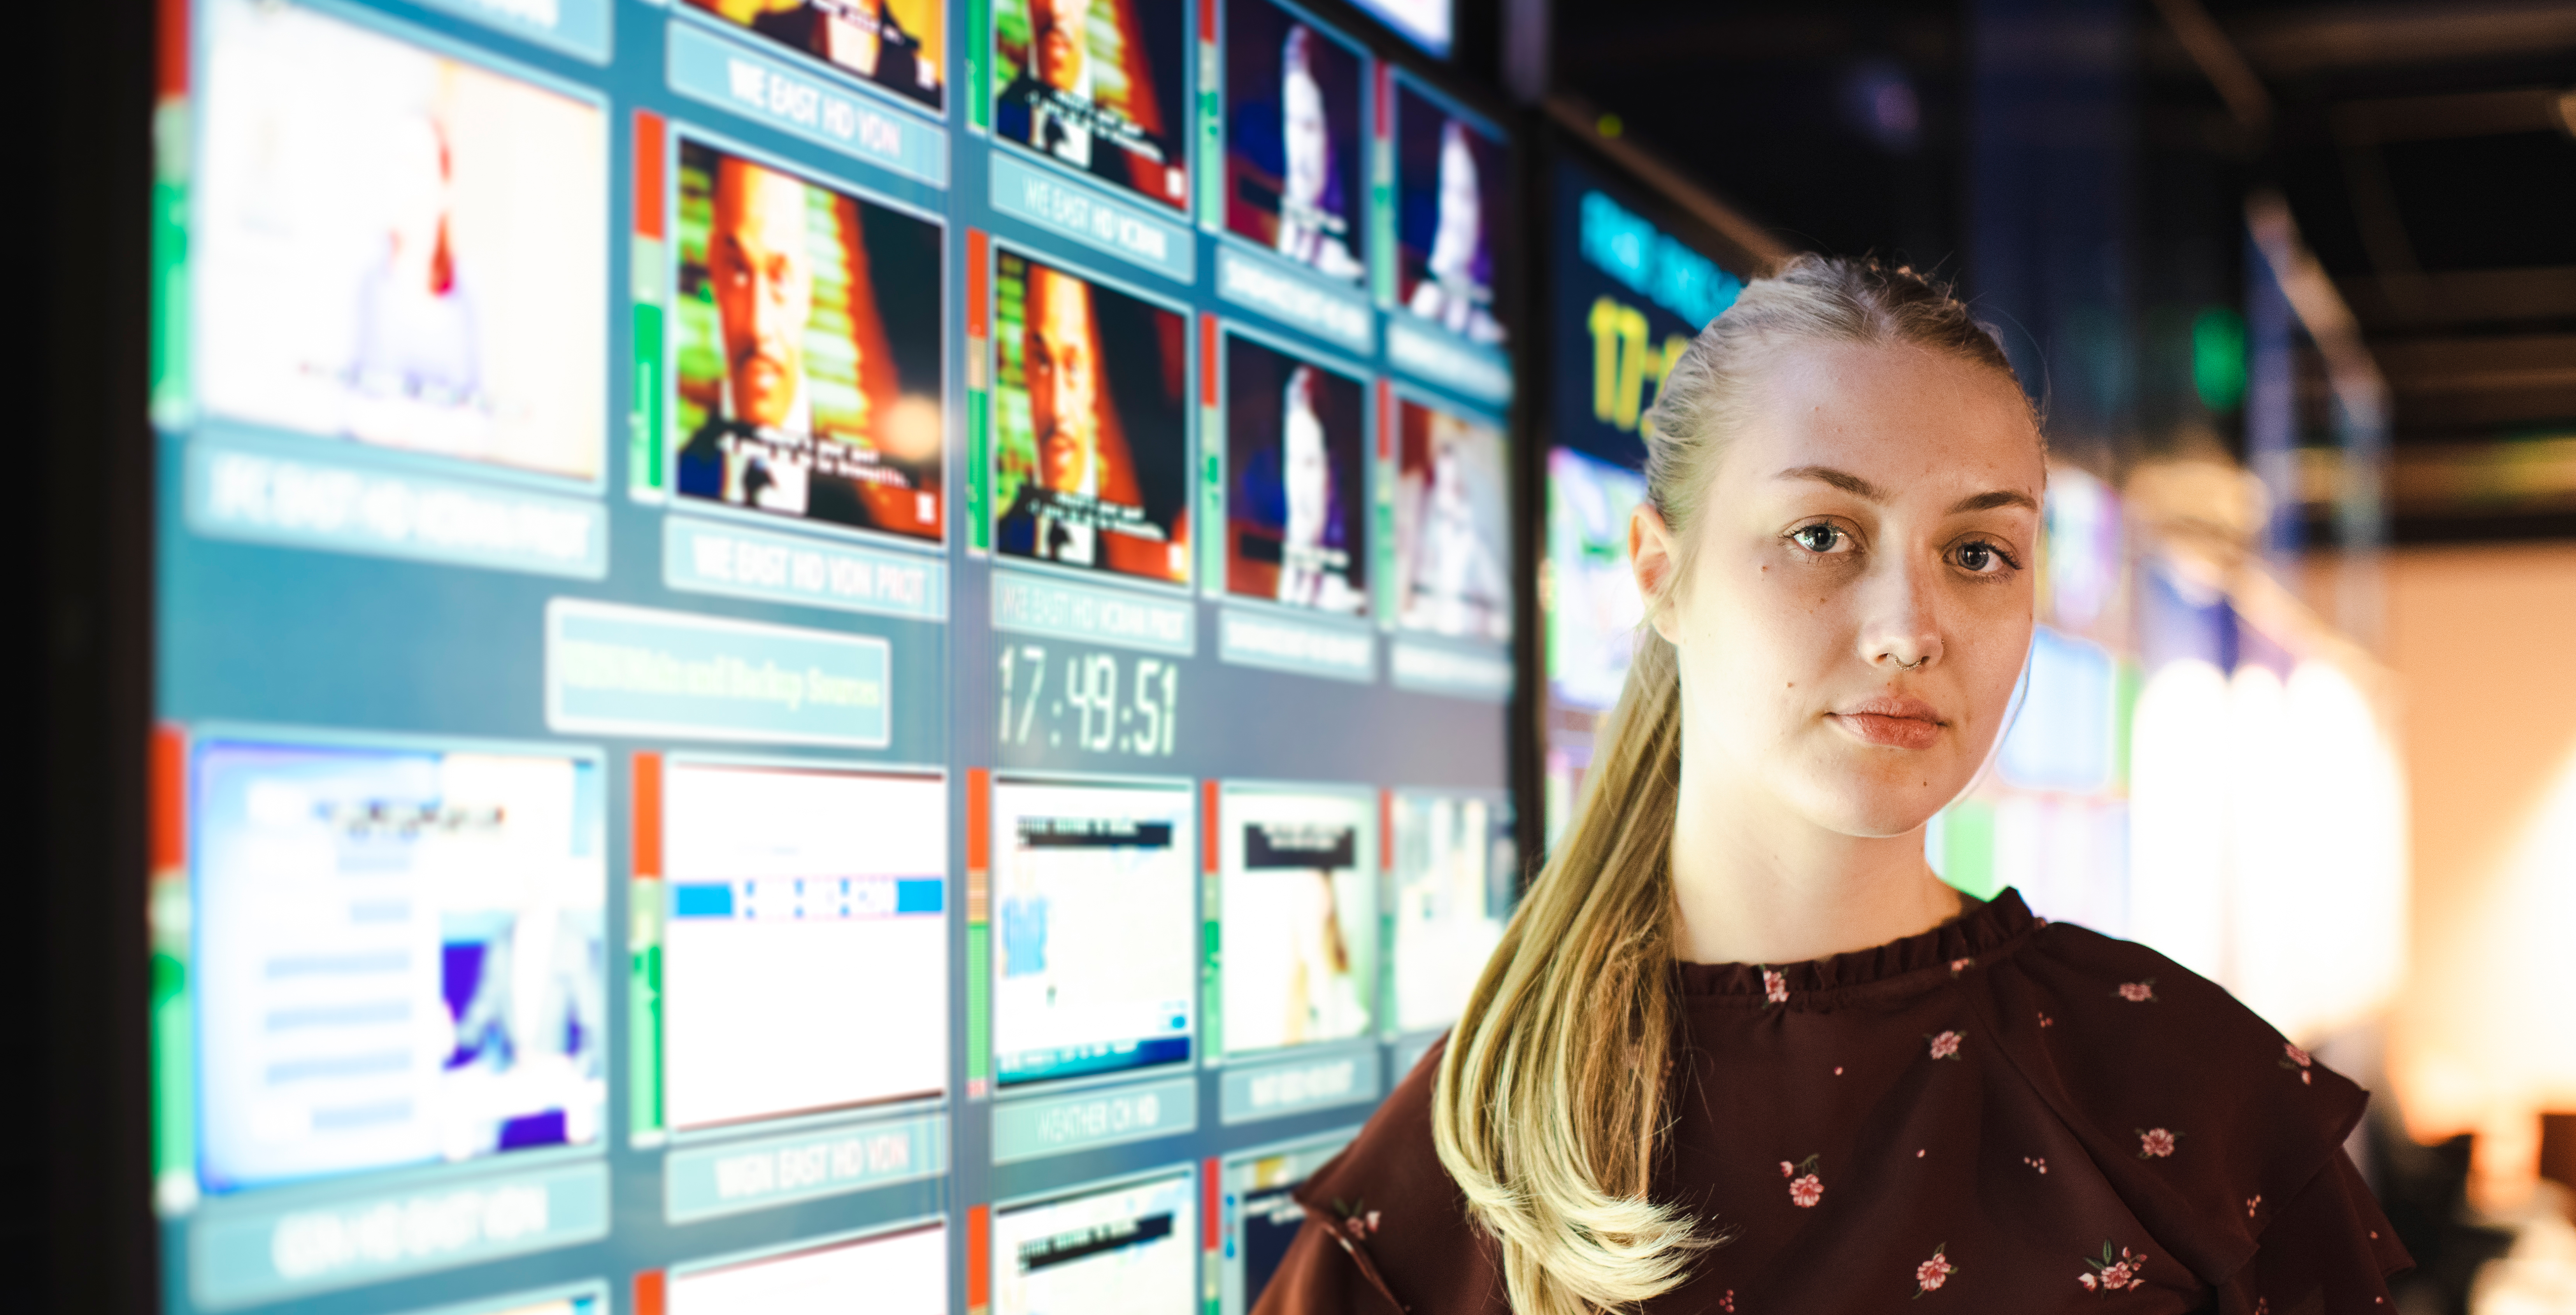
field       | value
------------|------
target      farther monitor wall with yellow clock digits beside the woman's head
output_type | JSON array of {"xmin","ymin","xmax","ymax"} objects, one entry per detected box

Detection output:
[{"xmin": 1541, "ymin": 149, "xmax": 1752, "ymax": 844}]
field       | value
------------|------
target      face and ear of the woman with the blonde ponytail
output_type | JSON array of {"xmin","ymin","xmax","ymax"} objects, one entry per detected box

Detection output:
[{"xmin": 1630, "ymin": 342, "xmax": 2045, "ymax": 836}]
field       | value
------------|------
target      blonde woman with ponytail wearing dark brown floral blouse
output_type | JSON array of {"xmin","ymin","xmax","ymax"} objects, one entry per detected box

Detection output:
[{"xmin": 1257, "ymin": 257, "xmax": 2409, "ymax": 1315}]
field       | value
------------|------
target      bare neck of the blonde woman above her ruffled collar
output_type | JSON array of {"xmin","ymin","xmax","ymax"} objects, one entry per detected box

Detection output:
[{"xmin": 1672, "ymin": 757, "xmax": 1968, "ymax": 963}]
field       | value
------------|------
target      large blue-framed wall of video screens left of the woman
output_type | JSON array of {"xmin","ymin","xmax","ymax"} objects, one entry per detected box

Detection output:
[{"xmin": 149, "ymin": 0, "xmax": 1528, "ymax": 1315}]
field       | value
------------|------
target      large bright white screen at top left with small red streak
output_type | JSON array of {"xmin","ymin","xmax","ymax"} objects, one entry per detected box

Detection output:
[{"xmin": 188, "ymin": 0, "xmax": 608, "ymax": 481}]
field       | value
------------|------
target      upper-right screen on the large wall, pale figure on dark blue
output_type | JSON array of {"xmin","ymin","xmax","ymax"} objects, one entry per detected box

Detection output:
[{"xmin": 1396, "ymin": 80, "xmax": 1512, "ymax": 342}]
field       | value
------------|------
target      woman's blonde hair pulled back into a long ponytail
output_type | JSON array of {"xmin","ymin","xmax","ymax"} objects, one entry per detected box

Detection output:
[{"xmin": 1432, "ymin": 255, "xmax": 2012, "ymax": 1315}]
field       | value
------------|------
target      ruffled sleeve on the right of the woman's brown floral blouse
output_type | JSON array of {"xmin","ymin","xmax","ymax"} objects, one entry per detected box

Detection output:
[{"xmin": 1983, "ymin": 924, "xmax": 2411, "ymax": 1315}]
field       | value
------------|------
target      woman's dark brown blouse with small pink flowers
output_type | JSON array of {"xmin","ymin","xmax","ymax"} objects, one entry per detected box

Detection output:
[{"xmin": 1255, "ymin": 891, "xmax": 2411, "ymax": 1315}]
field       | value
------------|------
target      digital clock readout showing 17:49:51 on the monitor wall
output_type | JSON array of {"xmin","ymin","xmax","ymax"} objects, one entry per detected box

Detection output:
[{"xmin": 1002, "ymin": 643, "xmax": 1180, "ymax": 759}]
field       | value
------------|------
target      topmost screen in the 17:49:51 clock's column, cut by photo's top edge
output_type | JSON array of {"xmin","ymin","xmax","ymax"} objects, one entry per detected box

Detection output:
[{"xmin": 992, "ymin": 0, "xmax": 1190, "ymax": 209}]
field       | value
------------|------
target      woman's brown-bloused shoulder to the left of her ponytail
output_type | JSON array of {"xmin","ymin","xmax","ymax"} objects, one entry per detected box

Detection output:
[{"xmin": 1260, "ymin": 1037, "xmax": 1509, "ymax": 1315}]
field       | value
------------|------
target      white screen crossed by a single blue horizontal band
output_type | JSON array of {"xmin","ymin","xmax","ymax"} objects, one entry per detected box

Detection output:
[{"xmin": 662, "ymin": 759, "xmax": 948, "ymax": 1130}]
